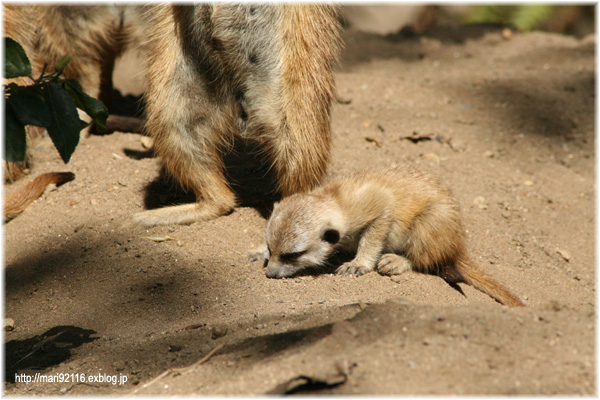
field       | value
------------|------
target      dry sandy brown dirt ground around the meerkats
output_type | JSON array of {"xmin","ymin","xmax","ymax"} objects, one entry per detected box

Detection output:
[{"xmin": 4, "ymin": 28, "xmax": 596, "ymax": 395}]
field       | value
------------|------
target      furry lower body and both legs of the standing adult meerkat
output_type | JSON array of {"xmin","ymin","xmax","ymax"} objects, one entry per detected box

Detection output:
[{"xmin": 133, "ymin": 3, "xmax": 339, "ymax": 226}]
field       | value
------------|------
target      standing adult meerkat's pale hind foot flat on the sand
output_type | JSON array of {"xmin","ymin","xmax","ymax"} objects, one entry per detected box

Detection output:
[{"xmin": 130, "ymin": 201, "xmax": 234, "ymax": 227}]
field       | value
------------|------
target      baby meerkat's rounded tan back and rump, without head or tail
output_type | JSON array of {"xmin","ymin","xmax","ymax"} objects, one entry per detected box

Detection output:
[{"xmin": 324, "ymin": 164, "xmax": 464, "ymax": 260}]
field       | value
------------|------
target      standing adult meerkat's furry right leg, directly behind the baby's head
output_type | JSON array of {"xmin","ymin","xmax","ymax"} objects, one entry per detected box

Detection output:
[{"xmin": 251, "ymin": 4, "xmax": 340, "ymax": 196}]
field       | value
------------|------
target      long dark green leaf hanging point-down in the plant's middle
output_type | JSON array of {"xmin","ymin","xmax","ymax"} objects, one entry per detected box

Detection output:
[{"xmin": 44, "ymin": 82, "xmax": 80, "ymax": 164}]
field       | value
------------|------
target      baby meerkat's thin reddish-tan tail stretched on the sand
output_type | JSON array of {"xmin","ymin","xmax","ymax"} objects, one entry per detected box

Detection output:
[{"xmin": 456, "ymin": 257, "xmax": 525, "ymax": 307}]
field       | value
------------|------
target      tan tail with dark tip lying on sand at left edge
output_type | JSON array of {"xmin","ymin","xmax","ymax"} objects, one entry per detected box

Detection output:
[{"xmin": 4, "ymin": 172, "xmax": 75, "ymax": 222}]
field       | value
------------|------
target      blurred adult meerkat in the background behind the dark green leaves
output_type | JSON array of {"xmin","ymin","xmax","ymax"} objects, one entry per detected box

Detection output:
[{"xmin": 2, "ymin": 3, "xmax": 142, "ymax": 182}]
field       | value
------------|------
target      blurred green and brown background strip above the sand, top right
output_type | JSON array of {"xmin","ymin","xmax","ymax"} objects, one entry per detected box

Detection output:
[{"xmin": 344, "ymin": 4, "xmax": 595, "ymax": 37}]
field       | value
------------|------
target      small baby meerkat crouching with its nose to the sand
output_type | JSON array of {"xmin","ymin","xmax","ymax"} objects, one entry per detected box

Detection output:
[{"xmin": 248, "ymin": 165, "xmax": 524, "ymax": 306}]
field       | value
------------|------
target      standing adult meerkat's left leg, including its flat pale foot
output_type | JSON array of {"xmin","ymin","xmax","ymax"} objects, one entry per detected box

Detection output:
[{"xmin": 133, "ymin": 5, "xmax": 235, "ymax": 226}]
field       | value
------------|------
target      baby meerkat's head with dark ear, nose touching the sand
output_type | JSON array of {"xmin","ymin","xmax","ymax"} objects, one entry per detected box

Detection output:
[{"xmin": 266, "ymin": 194, "xmax": 345, "ymax": 278}]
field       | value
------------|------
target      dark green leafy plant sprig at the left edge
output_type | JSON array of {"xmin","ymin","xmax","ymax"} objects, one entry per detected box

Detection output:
[{"xmin": 3, "ymin": 38, "xmax": 108, "ymax": 163}]
